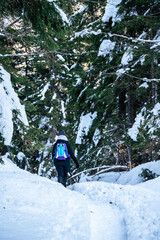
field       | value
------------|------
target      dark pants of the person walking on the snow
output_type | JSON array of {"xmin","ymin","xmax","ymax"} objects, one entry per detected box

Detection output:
[{"xmin": 55, "ymin": 164, "xmax": 70, "ymax": 187}]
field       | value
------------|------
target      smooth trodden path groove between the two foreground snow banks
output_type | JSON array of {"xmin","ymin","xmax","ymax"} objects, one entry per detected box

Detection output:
[{"xmin": 88, "ymin": 201, "xmax": 126, "ymax": 240}]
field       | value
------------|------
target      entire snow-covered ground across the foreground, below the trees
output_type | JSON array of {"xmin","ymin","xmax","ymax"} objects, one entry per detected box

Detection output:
[{"xmin": 0, "ymin": 157, "xmax": 160, "ymax": 240}]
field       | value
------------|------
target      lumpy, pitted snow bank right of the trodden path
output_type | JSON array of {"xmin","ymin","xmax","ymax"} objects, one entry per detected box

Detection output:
[{"xmin": 73, "ymin": 179, "xmax": 160, "ymax": 240}]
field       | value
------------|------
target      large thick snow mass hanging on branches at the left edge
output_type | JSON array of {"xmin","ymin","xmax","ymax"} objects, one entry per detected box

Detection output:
[{"xmin": 0, "ymin": 65, "xmax": 28, "ymax": 145}]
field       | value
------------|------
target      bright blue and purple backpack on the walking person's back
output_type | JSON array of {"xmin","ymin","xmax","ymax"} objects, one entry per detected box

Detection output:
[{"xmin": 55, "ymin": 143, "xmax": 70, "ymax": 160}]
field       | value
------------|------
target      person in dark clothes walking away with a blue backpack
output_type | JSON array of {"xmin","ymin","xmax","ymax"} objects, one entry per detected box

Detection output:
[{"xmin": 52, "ymin": 131, "xmax": 79, "ymax": 187}]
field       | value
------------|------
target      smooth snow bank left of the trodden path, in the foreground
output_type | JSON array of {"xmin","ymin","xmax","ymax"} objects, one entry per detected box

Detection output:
[{"xmin": 0, "ymin": 157, "xmax": 90, "ymax": 240}]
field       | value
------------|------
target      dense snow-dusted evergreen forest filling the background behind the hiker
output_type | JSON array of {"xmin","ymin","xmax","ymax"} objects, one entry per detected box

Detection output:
[{"xmin": 0, "ymin": 0, "xmax": 160, "ymax": 177}]
